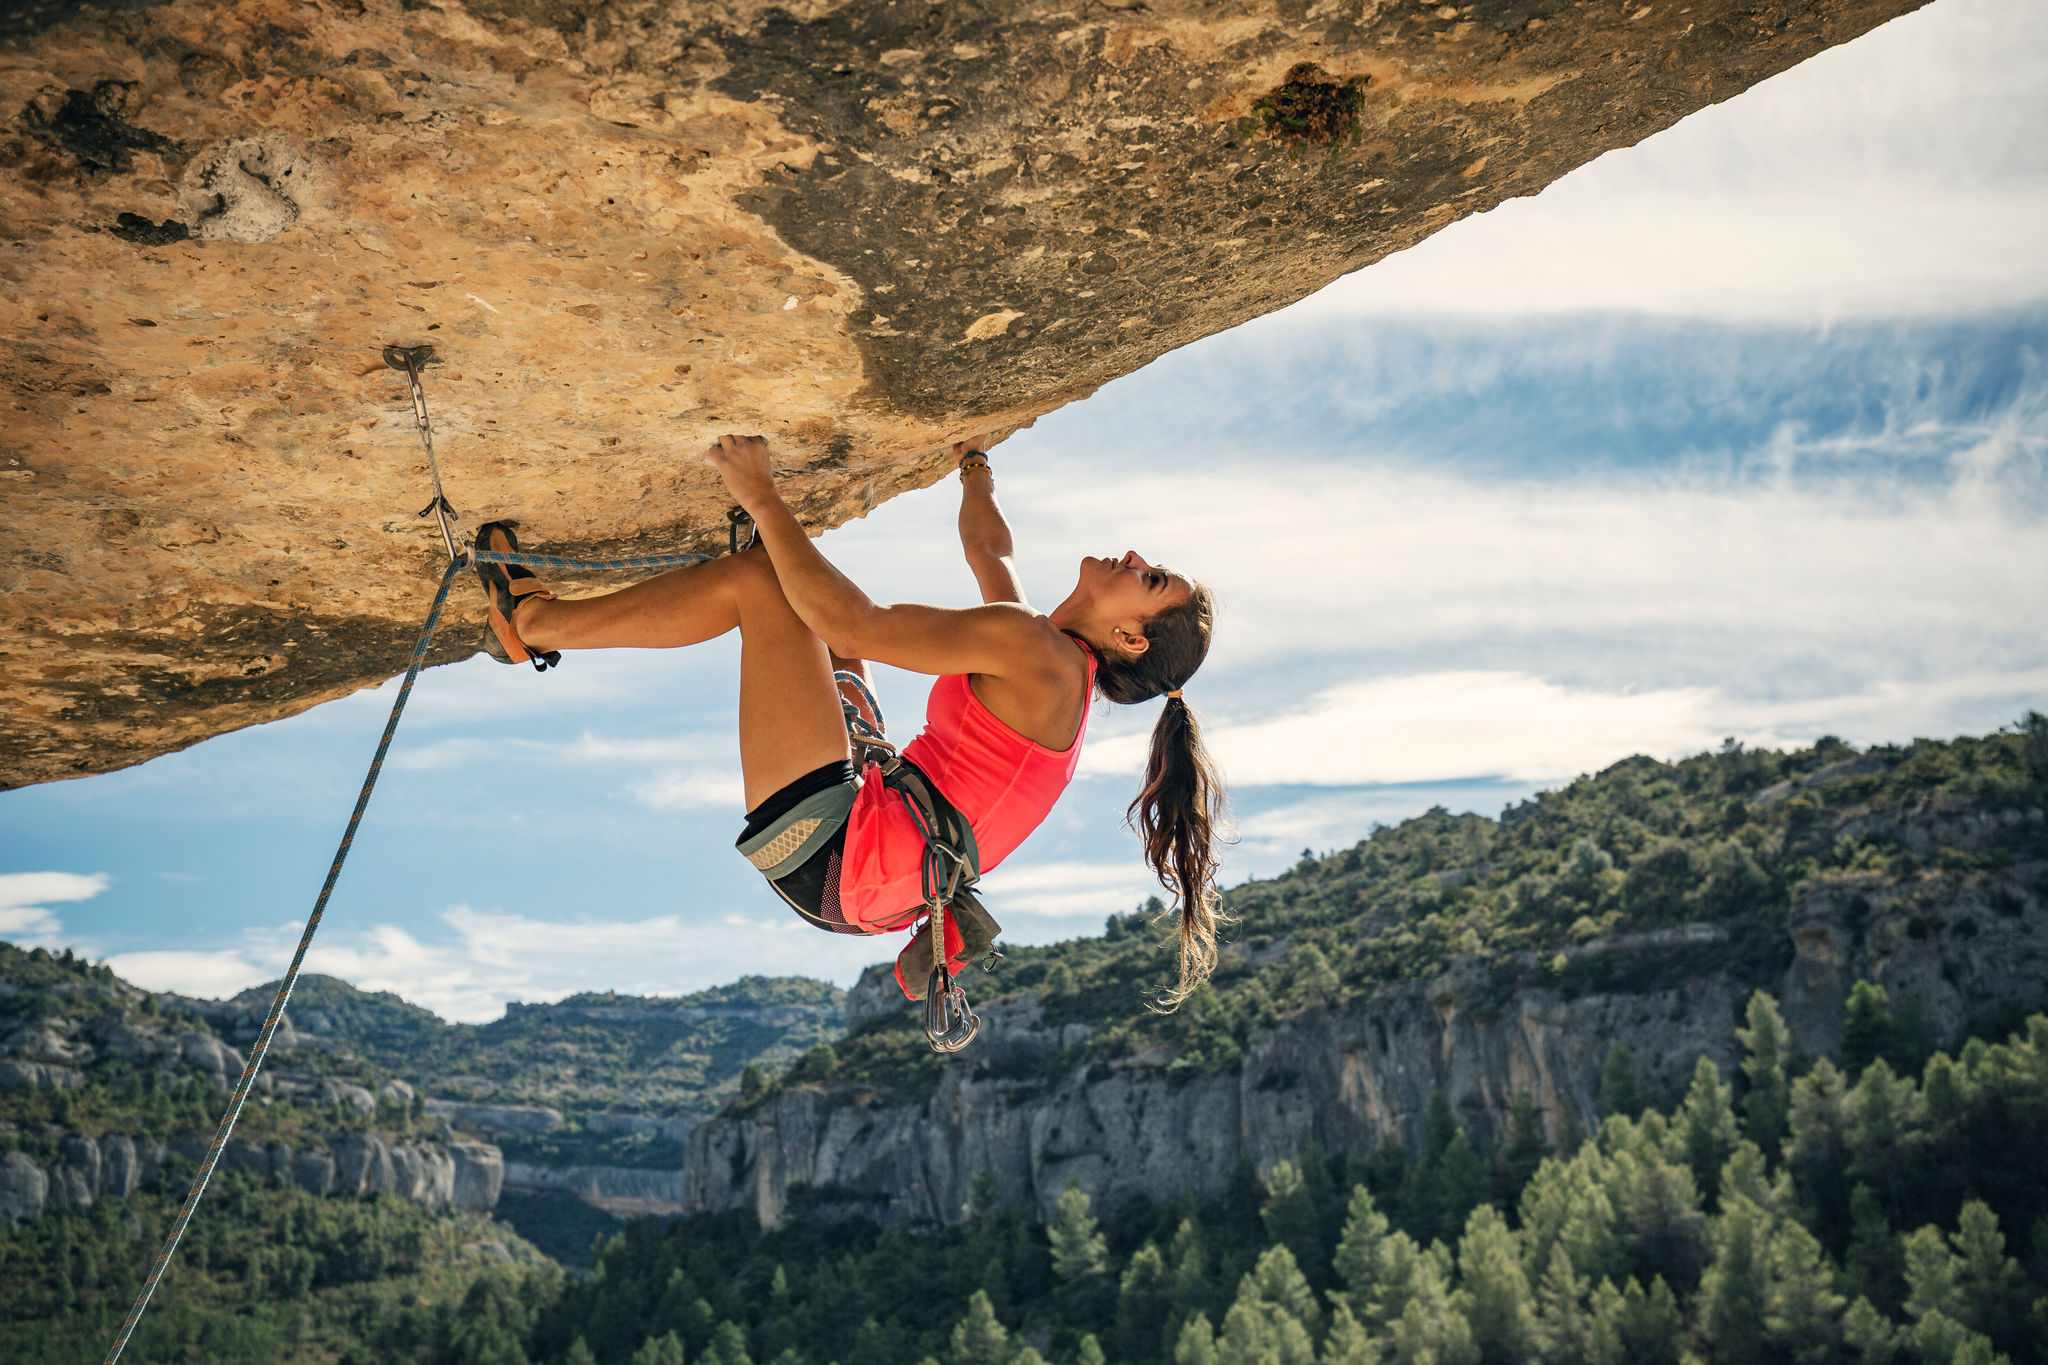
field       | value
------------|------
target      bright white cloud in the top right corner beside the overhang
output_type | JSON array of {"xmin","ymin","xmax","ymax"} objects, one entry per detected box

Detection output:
[{"xmin": 1300, "ymin": 0, "xmax": 2048, "ymax": 317}]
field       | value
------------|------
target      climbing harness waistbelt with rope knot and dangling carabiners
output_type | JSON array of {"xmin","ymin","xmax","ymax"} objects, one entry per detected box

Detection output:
[{"xmin": 831, "ymin": 671, "xmax": 1001, "ymax": 1052}]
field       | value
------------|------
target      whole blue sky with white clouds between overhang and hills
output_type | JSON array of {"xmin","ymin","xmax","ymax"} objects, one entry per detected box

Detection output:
[{"xmin": 0, "ymin": 0, "xmax": 2048, "ymax": 1019}]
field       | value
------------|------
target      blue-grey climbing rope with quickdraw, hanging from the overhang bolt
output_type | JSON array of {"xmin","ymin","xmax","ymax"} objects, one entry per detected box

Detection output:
[{"xmin": 104, "ymin": 346, "xmax": 739, "ymax": 1365}]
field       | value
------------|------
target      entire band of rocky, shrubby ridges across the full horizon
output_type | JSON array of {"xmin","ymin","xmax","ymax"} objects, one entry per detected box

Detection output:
[{"xmin": 0, "ymin": 718, "xmax": 2048, "ymax": 1246}]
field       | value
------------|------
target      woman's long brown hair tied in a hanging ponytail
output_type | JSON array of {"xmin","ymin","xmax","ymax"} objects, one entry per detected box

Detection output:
[{"xmin": 1094, "ymin": 583, "xmax": 1223, "ymax": 1009}]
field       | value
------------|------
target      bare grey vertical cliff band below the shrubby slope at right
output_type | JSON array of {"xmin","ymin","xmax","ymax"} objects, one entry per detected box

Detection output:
[{"xmin": 684, "ymin": 843, "xmax": 2048, "ymax": 1226}]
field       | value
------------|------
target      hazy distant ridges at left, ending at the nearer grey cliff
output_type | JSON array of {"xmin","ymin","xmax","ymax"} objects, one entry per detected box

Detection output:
[{"xmin": 0, "ymin": 957, "xmax": 844, "ymax": 1224}]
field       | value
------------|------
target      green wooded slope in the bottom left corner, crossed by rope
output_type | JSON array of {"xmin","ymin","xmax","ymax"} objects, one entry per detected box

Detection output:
[{"xmin": 0, "ymin": 1166, "xmax": 561, "ymax": 1365}]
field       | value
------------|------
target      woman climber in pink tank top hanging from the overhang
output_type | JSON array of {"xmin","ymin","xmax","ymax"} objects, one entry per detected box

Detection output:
[{"xmin": 477, "ymin": 436, "xmax": 1223, "ymax": 1003}]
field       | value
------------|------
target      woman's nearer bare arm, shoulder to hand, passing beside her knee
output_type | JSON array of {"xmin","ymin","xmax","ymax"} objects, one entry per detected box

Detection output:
[{"xmin": 711, "ymin": 436, "xmax": 1079, "ymax": 677}]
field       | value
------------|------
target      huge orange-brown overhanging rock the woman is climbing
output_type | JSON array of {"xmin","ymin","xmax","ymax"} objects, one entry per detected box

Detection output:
[{"xmin": 0, "ymin": 0, "xmax": 1919, "ymax": 786}]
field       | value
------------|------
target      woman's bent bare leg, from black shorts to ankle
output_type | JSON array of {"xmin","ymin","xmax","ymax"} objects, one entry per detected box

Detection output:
[{"xmin": 514, "ymin": 548, "xmax": 858, "ymax": 810}]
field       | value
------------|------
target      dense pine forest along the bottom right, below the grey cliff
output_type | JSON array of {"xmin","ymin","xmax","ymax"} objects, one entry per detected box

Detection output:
[{"xmin": 415, "ymin": 990, "xmax": 2048, "ymax": 1365}]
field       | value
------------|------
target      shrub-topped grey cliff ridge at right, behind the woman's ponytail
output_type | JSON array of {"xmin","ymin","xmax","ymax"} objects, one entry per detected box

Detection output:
[{"xmin": 684, "ymin": 732, "xmax": 2048, "ymax": 1224}]
